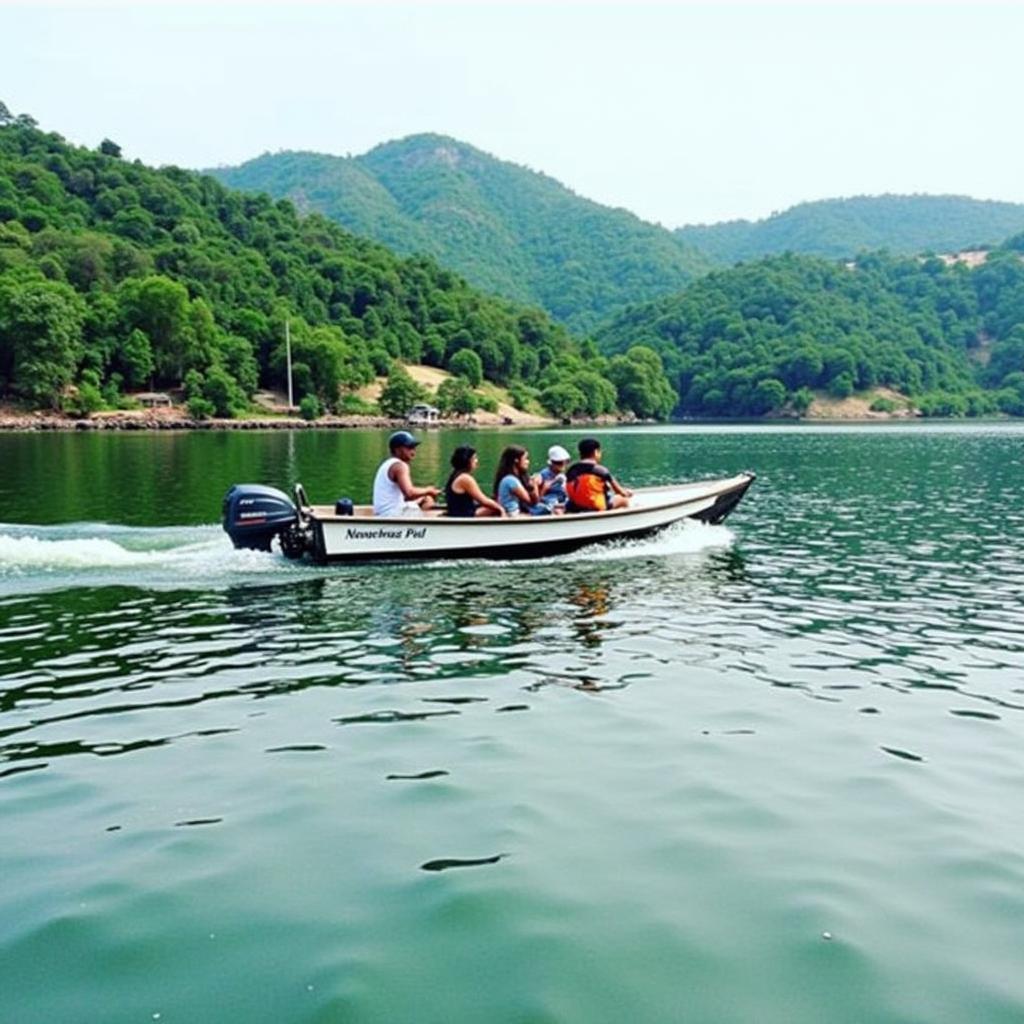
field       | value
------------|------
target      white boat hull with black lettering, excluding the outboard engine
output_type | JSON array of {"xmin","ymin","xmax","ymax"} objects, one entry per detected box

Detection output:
[{"xmin": 302, "ymin": 473, "xmax": 754, "ymax": 562}]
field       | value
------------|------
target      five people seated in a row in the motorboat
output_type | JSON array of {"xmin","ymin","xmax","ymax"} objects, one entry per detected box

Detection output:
[{"xmin": 374, "ymin": 430, "xmax": 633, "ymax": 519}]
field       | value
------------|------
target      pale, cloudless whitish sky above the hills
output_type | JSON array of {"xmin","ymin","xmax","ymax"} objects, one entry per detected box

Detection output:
[{"xmin": 0, "ymin": 0, "xmax": 1024, "ymax": 227}]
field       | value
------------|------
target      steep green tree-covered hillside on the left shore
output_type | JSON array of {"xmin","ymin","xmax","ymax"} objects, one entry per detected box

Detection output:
[{"xmin": 0, "ymin": 110, "xmax": 672, "ymax": 415}]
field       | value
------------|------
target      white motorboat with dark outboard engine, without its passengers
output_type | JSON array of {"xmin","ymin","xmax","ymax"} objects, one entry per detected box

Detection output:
[{"xmin": 223, "ymin": 473, "xmax": 755, "ymax": 564}]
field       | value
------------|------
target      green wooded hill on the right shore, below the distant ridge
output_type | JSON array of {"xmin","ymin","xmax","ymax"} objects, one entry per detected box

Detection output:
[{"xmin": 597, "ymin": 244, "xmax": 1024, "ymax": 416}]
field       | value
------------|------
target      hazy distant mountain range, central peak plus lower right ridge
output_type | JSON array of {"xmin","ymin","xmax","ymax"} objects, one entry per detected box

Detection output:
[{"xmin": 207, "ymin": 132, "xmax": 1024, "ymax": 334}]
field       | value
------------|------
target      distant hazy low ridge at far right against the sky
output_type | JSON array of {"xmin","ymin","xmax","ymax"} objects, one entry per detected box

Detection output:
[{"xmin": 676, "ymin": 196, "xmax": 1024, "ymax": 264}]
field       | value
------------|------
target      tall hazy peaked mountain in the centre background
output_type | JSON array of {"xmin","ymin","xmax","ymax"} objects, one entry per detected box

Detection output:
[{"xmin": 209, "ymin": 135, "xmax": 710, "ymax": 333}]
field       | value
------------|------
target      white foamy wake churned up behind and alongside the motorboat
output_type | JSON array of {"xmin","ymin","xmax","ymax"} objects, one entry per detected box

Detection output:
[{"xmin": 0, "ymin": 522, "xmax": 733, "ymax": 594}]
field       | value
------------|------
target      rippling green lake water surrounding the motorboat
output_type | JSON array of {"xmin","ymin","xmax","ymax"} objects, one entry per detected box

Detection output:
[{"xmin": 0, "ymin": 424, "xmax": 1024, "ymax": 1024}]
